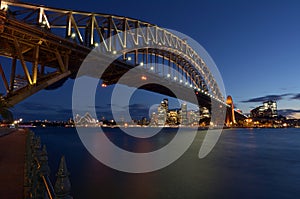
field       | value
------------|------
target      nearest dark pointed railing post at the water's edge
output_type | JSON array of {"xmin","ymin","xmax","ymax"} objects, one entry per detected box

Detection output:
[{"xmin": 54, "ymin": 156, "xmax": 73, "ymax": 199}]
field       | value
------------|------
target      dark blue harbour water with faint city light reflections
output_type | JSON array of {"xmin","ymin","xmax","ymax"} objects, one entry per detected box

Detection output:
[{"xmin": 33, "ymin": 128, "xmax": 300, "ymax": 199}]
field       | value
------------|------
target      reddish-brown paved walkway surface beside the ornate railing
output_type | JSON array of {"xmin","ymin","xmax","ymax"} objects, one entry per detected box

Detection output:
[{"xmin": 0, "ymin": 129, "xmax": 26, "ymax": 199}]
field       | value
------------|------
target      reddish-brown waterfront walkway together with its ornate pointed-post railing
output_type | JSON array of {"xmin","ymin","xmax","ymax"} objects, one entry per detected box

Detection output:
[{"xmin": 0, "ymin": 128, "xmax": 72, "ymax": 199}]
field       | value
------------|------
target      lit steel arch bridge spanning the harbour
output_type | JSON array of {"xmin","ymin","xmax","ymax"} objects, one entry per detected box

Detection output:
[{"xmin": 0, "ymin": 0, "xmax": 244, "ymax": 123}]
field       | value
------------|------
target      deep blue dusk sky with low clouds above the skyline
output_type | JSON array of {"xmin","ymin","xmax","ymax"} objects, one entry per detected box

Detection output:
[{"xmin": 5, "ymin": 0, "xmax": 300, "ymax": 120}]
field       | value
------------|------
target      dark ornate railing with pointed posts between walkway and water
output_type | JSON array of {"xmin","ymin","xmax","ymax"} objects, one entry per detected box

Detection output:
[{"xmin": 24, "ymin": 131, "xmax": 72, "ymax": 199}]
